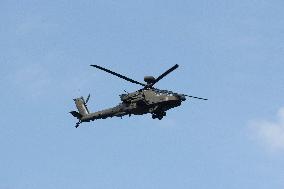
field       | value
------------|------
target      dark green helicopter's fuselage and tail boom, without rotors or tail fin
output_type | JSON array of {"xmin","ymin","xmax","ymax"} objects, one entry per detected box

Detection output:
[{"xmin": 81, "ymin": 89, "xmax": 185, "ymax": 122}]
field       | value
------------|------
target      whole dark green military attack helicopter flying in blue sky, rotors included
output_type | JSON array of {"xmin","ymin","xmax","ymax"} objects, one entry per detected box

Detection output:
[{"xmin": 70, "ymin": 64, "xmax": 208, "ymax": 128}]
